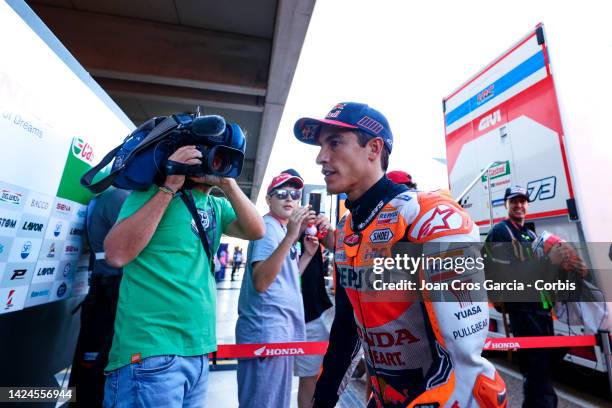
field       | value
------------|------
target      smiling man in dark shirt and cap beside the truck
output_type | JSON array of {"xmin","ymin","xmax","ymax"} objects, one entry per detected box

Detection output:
[{"xmin": 484, "ymin": 186, "xmax": 562, "ymax": 408}]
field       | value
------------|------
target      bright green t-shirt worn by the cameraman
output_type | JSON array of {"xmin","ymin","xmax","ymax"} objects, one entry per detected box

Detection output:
[{"xmin": 106, "ymin": 187, "xmax": 236, "ymax": 371}]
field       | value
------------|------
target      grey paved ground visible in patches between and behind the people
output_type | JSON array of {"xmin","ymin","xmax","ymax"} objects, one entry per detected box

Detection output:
[{"xmin": 208, "ymin": 280, "xmax": 612, "ymax": 408}]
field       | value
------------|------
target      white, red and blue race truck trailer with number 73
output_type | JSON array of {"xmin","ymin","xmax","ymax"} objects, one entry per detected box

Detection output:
[{"xmin": 443, "ymin": 24, "xmax": 612, "ymax": 372}]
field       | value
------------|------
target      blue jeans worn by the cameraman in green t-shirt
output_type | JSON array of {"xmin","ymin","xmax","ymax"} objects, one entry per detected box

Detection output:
[{"xmin": 104, "ymin": 355, "xmax": 208, "ymax": 408}]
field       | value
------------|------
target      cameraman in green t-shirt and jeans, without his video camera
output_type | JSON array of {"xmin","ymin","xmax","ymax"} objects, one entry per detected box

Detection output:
[{"xmin": 104, "ymin": 146, "xmax": 265, "ymax": 407}]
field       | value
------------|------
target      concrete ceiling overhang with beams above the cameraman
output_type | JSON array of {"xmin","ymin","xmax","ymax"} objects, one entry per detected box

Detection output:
[{"xmin": 26, "ymin": 0, "xmax": 315, "ymax": 201}]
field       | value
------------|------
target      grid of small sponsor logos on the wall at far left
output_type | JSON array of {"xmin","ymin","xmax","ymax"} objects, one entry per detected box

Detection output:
[{"xmin": 0, "ymin": 181, "xmax": 88, "ymax": 314}]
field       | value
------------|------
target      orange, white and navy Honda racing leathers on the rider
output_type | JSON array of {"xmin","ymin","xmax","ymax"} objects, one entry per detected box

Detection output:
[{"xmin": 314, "ymin": 176, "xmax": 507, "ymax": 408}]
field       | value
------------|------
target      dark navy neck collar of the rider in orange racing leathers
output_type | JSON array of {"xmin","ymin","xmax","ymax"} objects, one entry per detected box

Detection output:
[{"xmin": 344, "ymin": 175, "xmax": 408, "ymax": 231}]
